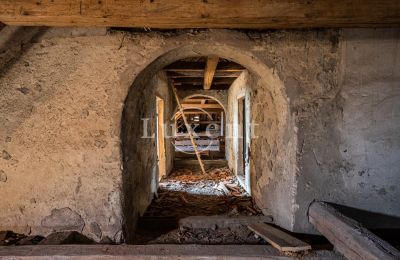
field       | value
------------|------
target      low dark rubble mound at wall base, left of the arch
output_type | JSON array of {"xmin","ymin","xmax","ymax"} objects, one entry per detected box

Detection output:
[{"xmin": 39, "ymin": 231, "xmax": 95, "ymax": 245}]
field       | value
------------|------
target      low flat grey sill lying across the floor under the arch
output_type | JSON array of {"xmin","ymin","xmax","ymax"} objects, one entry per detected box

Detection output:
[{"xmin": 179, "ymin": 215, "xmax": 272, "ymax": 228}]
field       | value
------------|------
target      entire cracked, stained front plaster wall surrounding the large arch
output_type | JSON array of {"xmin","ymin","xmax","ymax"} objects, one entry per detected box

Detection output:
[{"xmin": 0, "ymin": 25, "xmax": 400, "ymax": 241}]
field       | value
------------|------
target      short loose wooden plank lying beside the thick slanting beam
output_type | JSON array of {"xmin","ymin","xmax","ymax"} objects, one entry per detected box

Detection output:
[{"xmin": 248, "ymin": 224, "xmax": 311, "ymax": 252}]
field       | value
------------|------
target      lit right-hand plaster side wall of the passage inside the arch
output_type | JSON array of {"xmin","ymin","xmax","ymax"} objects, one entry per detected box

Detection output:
[{"xmin": 227, "ymin": 71, "xmax": 295, "ymax": 229}]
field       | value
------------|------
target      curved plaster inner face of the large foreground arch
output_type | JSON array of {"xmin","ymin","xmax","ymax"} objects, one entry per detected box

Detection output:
[{"xmin": 121, "ymin": 44, "xmax": 295, "ymax": 242}]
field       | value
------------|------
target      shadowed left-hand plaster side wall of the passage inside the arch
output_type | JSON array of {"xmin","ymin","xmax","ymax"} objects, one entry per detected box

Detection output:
[{"xmin": 122, "ymin": 71, "xmax": 174, "ymax": 241}]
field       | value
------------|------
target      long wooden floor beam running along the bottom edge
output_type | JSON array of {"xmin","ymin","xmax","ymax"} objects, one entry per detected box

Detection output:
[{"xmin": 0, "ymin": 245, "xmax": 343, "ymax": 260}]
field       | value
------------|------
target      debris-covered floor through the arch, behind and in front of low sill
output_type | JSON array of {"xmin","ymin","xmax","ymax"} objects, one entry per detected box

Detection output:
[{"xmin": 136, "ymin": 168, "xmax": 265, "ymax": 244}]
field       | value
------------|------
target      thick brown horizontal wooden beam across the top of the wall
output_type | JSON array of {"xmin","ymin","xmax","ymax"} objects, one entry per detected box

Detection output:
[{"xmin": 0, "ymin": 0, "xmax": 400, "ymax": 29}]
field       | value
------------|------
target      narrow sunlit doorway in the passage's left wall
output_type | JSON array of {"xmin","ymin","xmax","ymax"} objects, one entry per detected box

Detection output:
[{"xmin": 156, "ymin": 97, "xmax": 166, "ymax": 181}]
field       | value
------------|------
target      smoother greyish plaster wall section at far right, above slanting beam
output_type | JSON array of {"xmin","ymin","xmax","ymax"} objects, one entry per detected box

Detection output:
[{"xmin": 295, "ymin": 29, "xmax": 400, "ymax": 234}]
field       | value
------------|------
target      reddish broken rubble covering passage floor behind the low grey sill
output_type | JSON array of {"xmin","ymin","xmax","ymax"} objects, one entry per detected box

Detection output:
[{"xmin": 145, "ymin": 168, "xmax": 262, "ymax": 218}]
